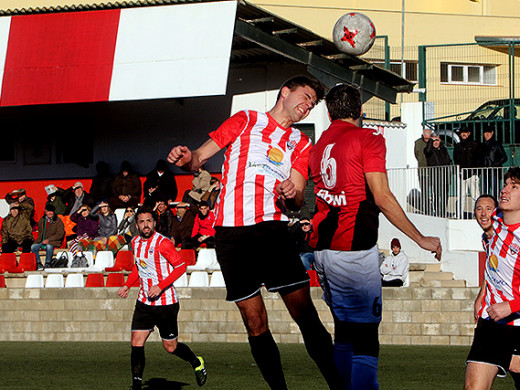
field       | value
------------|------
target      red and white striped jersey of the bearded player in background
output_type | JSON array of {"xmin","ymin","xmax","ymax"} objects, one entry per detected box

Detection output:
[{"xmin": 129, "ymin": 232, "xmax": 184, "ymax": 306}]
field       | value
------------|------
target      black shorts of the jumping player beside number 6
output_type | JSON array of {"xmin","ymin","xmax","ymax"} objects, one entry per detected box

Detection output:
[{"xmin": 215, "ymin": 221, "xmax": 309, "ymax": 302}]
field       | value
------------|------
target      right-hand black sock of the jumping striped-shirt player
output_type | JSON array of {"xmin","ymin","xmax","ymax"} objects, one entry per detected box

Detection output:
[{"xmin": 298, "ymin": 311, "xmax": 345, "ymax": 389}]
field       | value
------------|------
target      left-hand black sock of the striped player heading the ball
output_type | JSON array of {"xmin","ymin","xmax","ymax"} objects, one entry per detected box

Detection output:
[{"xmin": 249, "ymin": 330, "xmax": 287, "ymax": 390}]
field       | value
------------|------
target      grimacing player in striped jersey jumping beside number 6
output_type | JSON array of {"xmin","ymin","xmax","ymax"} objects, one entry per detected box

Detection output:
[{"xmin": 168, "ymin": 76, "xmax": 343, "ymax": 389}]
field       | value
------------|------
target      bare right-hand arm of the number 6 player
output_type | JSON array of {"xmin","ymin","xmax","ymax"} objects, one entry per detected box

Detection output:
[{"xmin": 365, "ymin": 172, "xmax": 442, "ymax": 261}]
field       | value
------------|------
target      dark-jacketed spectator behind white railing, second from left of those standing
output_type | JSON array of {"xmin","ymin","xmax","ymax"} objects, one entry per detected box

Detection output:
[{"xmin": 424, "ymin": 133, "xmax": 451, "ymax": 218}]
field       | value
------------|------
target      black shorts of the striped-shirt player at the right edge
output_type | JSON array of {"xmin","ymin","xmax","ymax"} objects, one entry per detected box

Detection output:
[{"xmin": 466, "ymin": 318, "xmax": 520, "ymax": 377}]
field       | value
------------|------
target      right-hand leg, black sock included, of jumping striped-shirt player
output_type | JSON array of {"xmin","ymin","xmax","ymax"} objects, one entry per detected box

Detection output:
[{"xmin": 282, "ymin": 285, "xmax": 345, "ymax": 389}]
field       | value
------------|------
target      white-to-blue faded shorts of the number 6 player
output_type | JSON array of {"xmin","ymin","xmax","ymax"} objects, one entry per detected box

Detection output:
[{"xmin": 314, "ymin": 246, "xmax": 382, "ymax": 323}]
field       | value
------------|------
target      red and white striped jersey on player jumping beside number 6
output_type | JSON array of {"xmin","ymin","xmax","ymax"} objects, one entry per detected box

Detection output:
[{"xmin": 209, "ymin": 111, "xmax": 311, "ymax": 226}]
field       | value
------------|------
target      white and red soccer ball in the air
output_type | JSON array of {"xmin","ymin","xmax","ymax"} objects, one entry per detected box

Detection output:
[{"xmin": 332, "ymin": 12, "xmax": 376, "ymax": 56}]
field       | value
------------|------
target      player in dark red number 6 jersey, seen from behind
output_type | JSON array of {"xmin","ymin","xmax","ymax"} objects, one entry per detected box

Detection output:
[{"xmin": 309, "ymin": 85, "xmax": 442, "ymax": 390}]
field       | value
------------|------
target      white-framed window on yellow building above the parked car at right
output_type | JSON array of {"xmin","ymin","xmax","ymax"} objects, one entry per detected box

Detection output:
[{"xmin": 441, "ymin": 62, "xmax": 497, "ymax": 85}]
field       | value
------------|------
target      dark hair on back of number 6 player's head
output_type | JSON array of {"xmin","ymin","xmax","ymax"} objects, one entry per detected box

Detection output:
[{"xmin": 325, "ymin": 84, "xmax": 361, "ymax": 120}]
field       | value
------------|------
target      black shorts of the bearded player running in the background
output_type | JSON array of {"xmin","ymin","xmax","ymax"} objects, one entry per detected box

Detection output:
[{"xmin": 132, "ymin": 301, "xmax": 179, "ymax": 340}]
